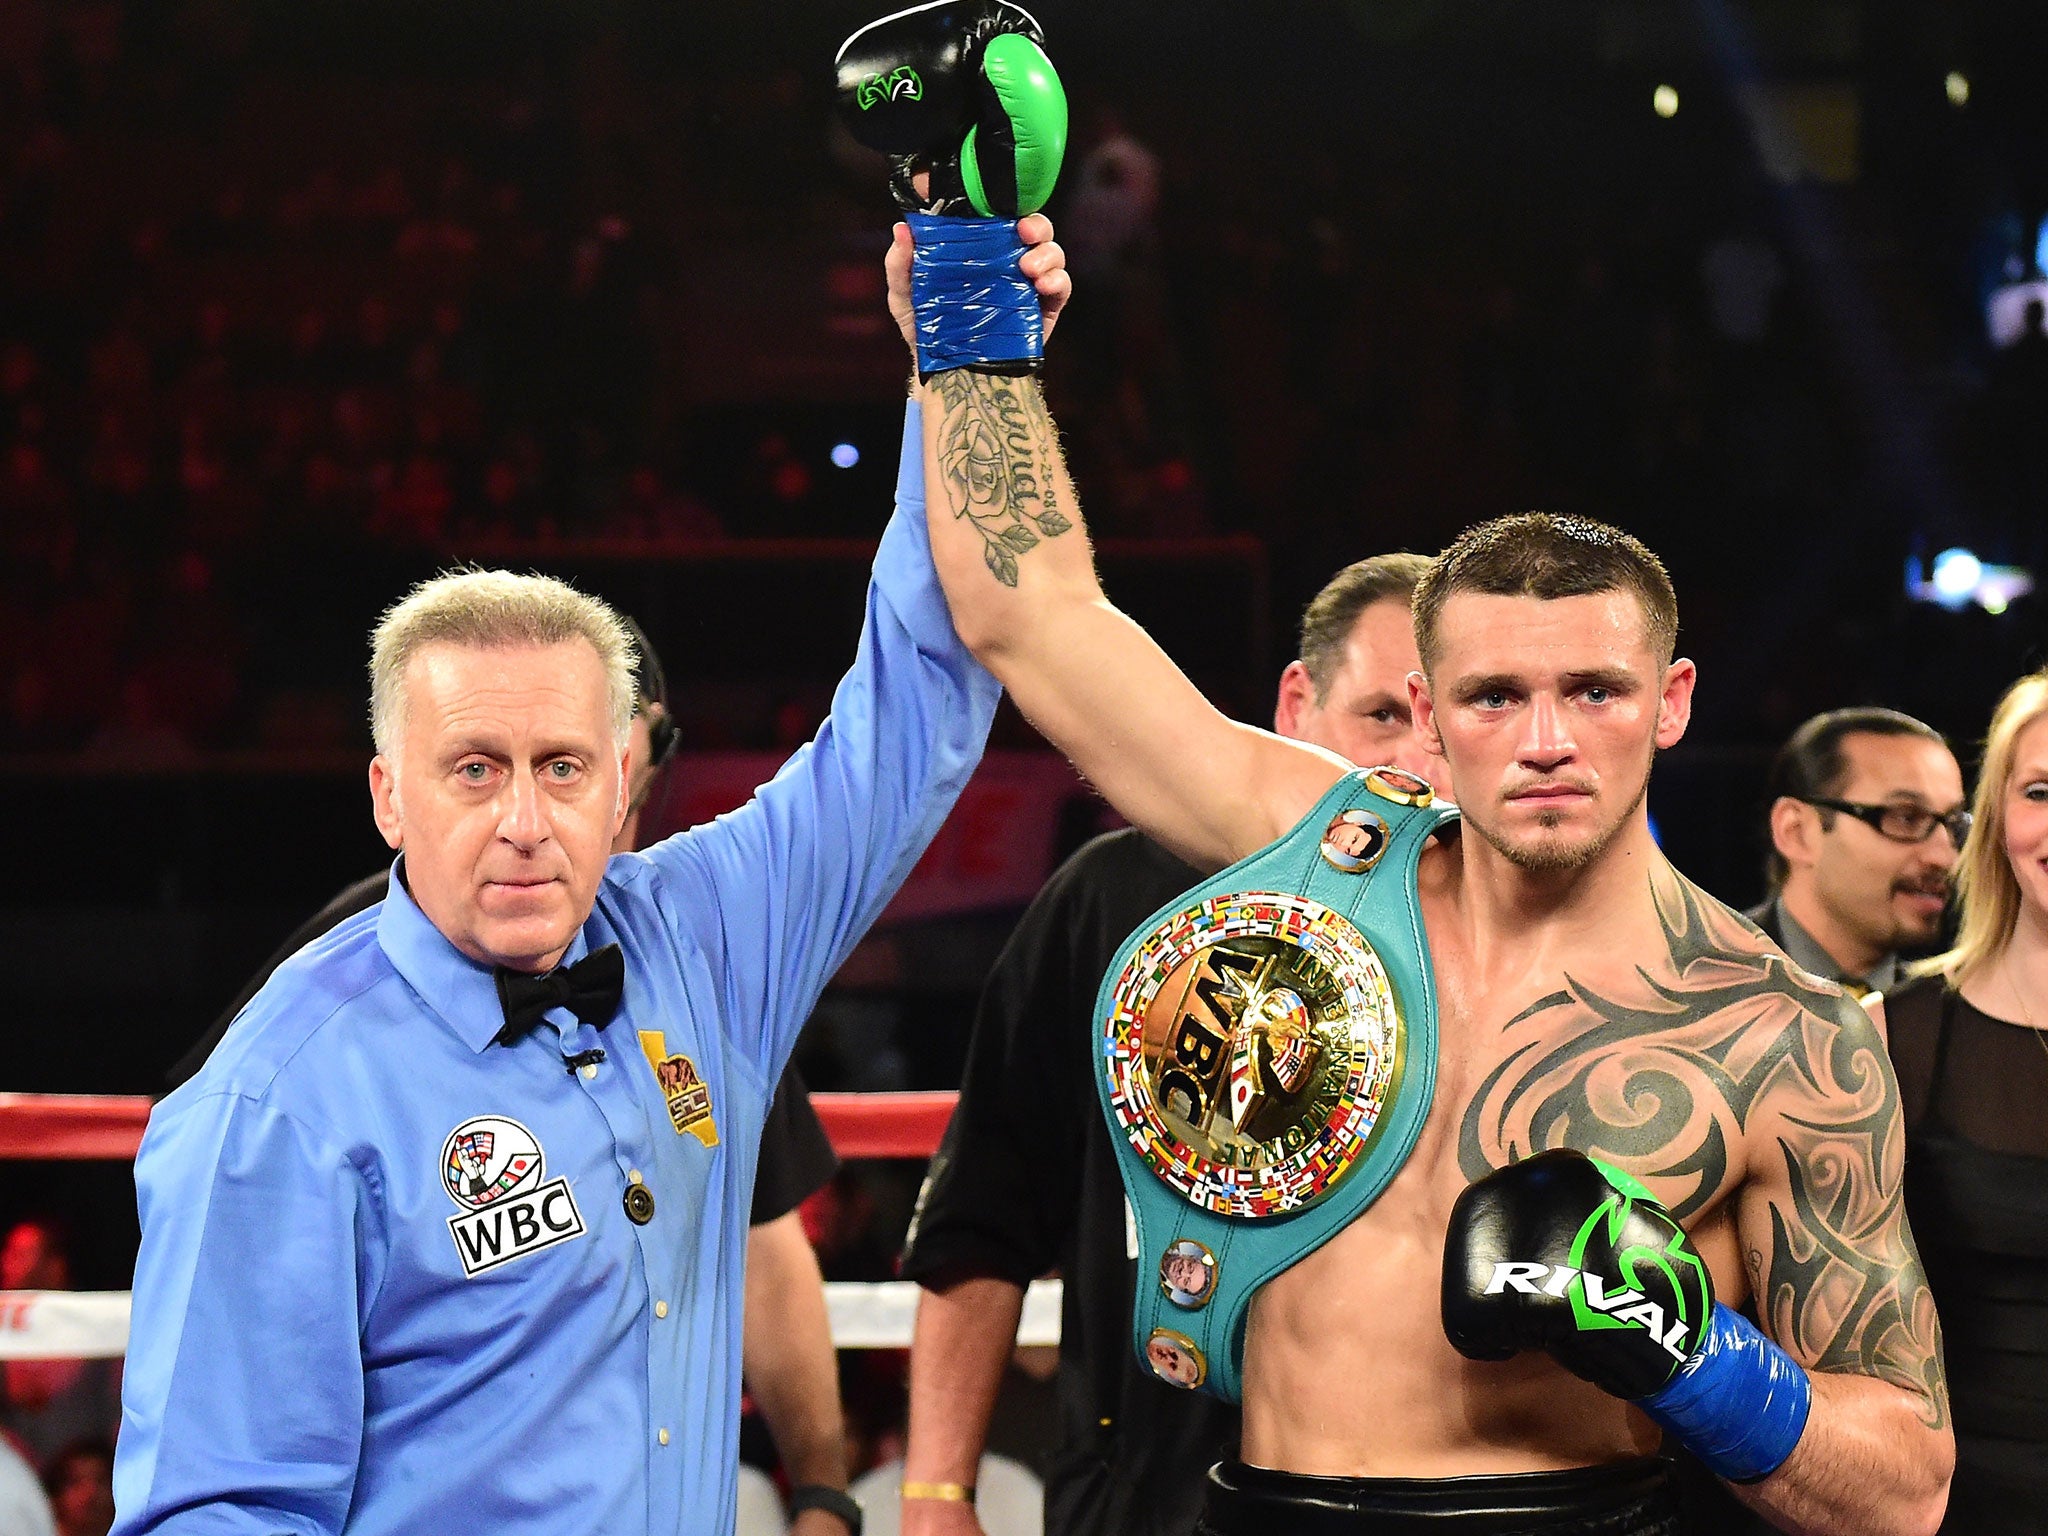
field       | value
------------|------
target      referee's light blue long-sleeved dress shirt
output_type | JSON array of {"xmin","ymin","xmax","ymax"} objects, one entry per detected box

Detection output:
[{"xmin": 115, "ymin": 406, "xmax": 999, "ymax": 1536}]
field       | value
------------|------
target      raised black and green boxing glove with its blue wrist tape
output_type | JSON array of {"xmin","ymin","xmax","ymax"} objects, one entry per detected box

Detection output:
[{"xmin": 838, "ymin": 0, "xmax": 1067, "ymax": 377}]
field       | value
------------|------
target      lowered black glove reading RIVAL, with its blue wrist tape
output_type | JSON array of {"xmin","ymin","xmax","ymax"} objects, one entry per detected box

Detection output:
[{"xmin": 1444, "ymin": 1149, "xmax": 1812, "ymax": 1483}]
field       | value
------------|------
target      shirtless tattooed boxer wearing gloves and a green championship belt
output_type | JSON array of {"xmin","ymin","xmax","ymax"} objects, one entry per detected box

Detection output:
[{"xmin": 840, "ymin": 4, "xmax": 1954, "ymax": 1536}]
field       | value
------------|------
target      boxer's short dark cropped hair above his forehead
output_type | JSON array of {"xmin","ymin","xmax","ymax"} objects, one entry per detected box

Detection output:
[{"xmin": 1415, "ymin": 512, "xmax": 1677, "ymax": 672}]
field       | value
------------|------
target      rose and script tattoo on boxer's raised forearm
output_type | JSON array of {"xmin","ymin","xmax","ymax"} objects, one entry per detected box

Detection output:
[{"xmin": 932, "ymin": 369, "xmax": 1073, "ymax": 586}]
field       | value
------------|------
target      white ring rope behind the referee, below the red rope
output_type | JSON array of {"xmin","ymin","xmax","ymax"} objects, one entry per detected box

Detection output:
[{"xmin": 0, "ymin": 1280, "xmax": 1061, "ymax": 1360}]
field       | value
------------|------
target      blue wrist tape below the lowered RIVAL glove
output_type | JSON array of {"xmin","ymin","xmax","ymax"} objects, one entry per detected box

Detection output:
[{"xmin": 1636, "ymin": 1303, "xmax": 1812, "ymax": 1483}]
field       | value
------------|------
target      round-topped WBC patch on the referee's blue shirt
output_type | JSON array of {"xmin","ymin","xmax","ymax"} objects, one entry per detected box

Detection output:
[{"xmin": 440, "ymin": 1114, "xmax": 584, "ymax": 1280}]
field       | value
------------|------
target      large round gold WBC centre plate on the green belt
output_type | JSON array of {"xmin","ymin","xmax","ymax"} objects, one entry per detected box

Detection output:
[{"xmin": 1102, "ymin": 891, "xmax": 1403, "ymax": 1217}]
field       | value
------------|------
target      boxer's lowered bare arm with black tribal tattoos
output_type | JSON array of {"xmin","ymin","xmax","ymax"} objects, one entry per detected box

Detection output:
[{"xmin": 1735, "ymin": 989, "xmax": 1956, "ymax": 1536}]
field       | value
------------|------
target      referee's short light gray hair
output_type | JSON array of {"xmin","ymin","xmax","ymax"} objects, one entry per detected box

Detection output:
[{"xmin": 371, "ymin": 567, "xmax": 639, "ymax": 756}]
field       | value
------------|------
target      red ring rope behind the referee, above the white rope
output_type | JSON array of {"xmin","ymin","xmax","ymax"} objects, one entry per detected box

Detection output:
[{"xmin": 0, "ymin": 1090, "xmax": 958, "ymax": 1161}]
